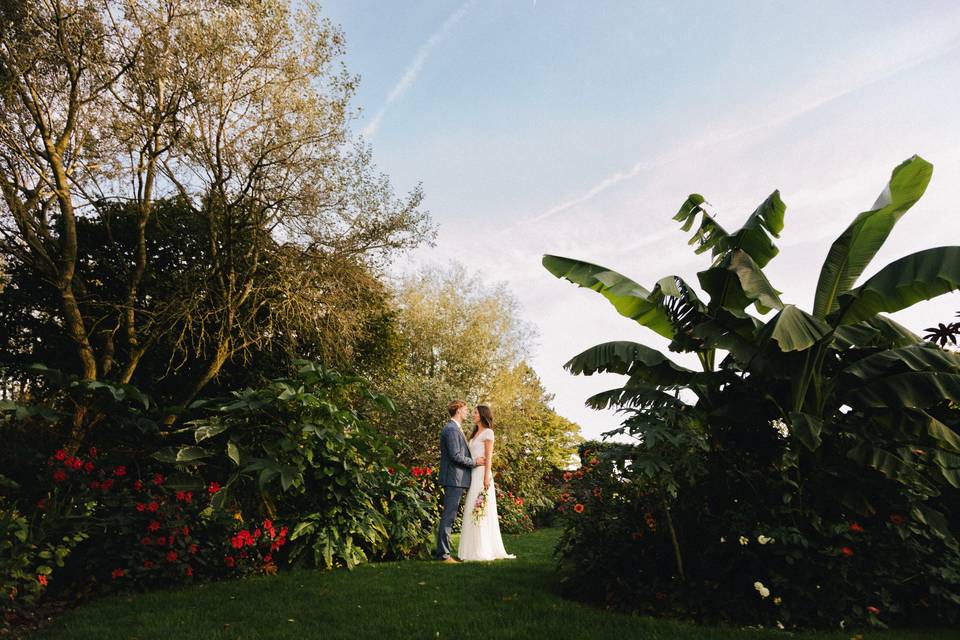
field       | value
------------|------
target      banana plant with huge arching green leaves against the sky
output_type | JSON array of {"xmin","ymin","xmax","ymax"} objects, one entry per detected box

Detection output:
[{"xmin": 543, "ymin": 156, "xmax": 960, "ymax": 520}]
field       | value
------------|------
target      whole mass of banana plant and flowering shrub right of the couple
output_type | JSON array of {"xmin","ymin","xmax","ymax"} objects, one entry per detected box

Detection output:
[{"xmin": 544, "ymin": 157, "xmax": 960, "ymax": 626}]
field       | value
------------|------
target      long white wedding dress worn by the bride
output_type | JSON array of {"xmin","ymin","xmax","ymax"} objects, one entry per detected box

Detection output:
[{"xmin": 457, "ymin": 429, "xmax": 516, "ymax": 560}]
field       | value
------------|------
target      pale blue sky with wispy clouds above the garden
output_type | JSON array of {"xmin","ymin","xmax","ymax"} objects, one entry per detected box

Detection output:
[{"xmin": 322, "ymin": 0, "xmax": 960, "ymax": 437}]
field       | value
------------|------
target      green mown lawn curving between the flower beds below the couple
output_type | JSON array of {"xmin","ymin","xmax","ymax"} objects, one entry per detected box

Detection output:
[{"xmin": 32, "ymin": 530, "xmax": 956, "ymax": 640}]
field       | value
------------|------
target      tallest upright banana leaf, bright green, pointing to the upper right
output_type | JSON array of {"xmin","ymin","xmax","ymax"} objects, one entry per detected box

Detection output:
[{"xmin": 813, "ymin": 156, "xmax": 933, "ymax": 318}]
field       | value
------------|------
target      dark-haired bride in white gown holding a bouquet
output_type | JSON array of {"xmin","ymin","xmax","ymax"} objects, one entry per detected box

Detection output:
[{"xmin": 457, "ymin": 404, "xmax": 516, "ymax": 560}]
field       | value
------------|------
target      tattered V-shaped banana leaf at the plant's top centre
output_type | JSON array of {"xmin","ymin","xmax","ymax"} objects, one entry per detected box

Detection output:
[{"xmin": 673, "ymin": 191, "xmax": 787, "ymax": 268}]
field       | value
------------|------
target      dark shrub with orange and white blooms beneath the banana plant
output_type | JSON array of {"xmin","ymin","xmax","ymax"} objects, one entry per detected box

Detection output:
[{"xmin": 557, "ymin": 436, "xmax": 960, "ymax": 627}]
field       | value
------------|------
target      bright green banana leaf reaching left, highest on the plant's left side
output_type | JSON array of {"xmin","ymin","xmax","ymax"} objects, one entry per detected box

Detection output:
[{"xmin": 543, "ymin": 255, "xmax": 675, "ymax": 340}]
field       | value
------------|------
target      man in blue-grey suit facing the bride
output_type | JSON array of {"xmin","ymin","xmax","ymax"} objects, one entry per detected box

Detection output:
[{"xmin": 437, "ymin": 400, "xmax": 485, "ymax": 562}]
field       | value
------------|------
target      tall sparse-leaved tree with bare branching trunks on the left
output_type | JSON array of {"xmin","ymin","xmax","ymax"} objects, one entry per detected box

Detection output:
[{"xmin": 0, "ymin": 0, "xmax": 431, "ymax": 435}]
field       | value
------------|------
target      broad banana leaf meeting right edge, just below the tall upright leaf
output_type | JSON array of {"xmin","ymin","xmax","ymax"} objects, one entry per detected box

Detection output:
[{"xmin": 838, "ymin": 247, "xmax": 960, "ymax": 325}]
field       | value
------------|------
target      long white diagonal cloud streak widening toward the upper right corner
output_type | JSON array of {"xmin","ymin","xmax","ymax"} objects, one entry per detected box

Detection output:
[{"xmin": 527, "ymin": 23, "xmax": 960, "ymax": 222}]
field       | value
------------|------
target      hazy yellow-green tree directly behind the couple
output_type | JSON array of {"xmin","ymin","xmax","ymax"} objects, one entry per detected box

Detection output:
[{"xmin": 380, "ymin": 264, "xmax": 578, "ymax": 492}]
